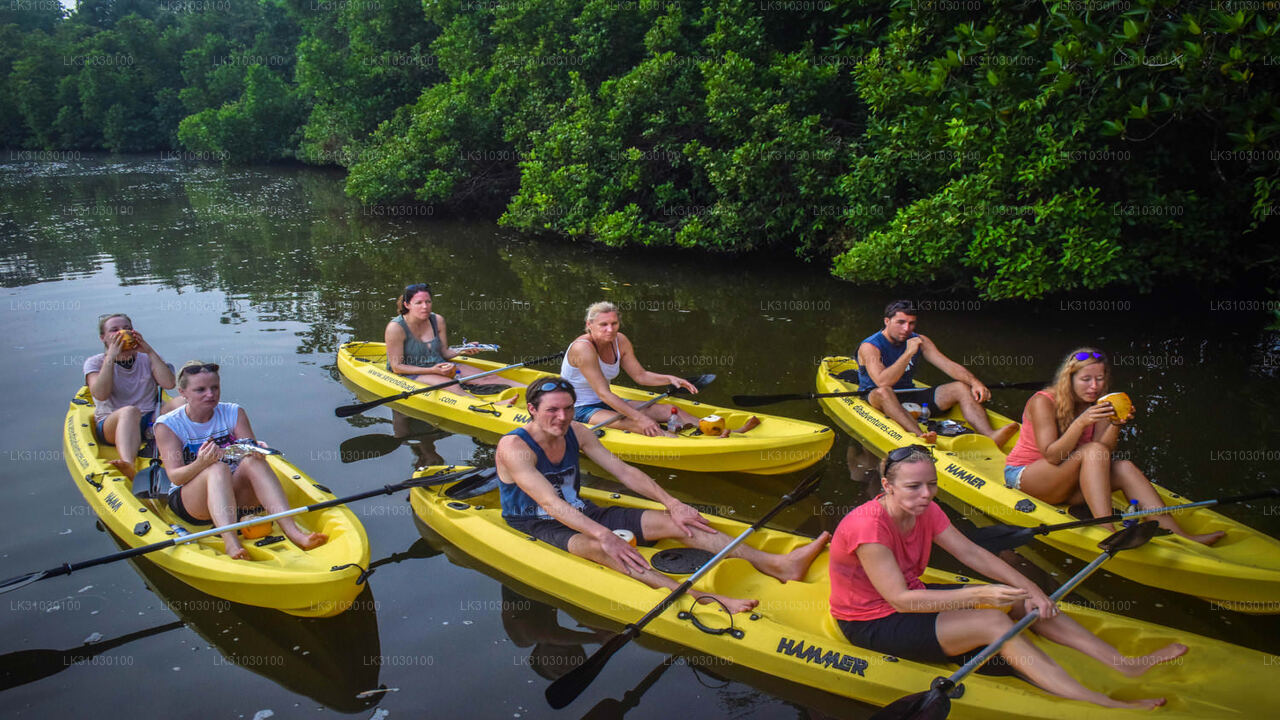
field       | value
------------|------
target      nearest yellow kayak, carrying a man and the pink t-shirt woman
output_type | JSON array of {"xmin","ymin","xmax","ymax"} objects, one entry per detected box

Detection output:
[{"xmin": 410, "ymin": 468, "xmax": 1280, "ymax": 719}]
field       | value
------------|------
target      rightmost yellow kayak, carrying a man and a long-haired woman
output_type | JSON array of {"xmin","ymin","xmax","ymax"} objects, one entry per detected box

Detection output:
[{"xmin": 818, "ymin": 357, "xmax": 1280, "ymax": 614}]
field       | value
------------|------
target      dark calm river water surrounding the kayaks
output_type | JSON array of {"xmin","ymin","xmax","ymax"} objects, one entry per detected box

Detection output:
[{"xmin": 0, "ymin": 156, "xmax": 1280, "ymax": 717}]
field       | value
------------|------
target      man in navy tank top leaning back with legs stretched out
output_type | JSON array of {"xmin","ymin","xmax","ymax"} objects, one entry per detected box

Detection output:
[{"xmin": 495, "ymin": 375, "xmax": 831, "ymax": 612}]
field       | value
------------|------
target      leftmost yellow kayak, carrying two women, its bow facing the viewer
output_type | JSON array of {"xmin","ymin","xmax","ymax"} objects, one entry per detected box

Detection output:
[{"xmin": 63, "ymin": 387, "xmax": 369, "ymax": 618}]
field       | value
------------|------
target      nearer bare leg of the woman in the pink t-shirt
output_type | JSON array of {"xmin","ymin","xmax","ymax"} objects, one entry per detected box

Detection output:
[{"xmin": 937, "ymin": 610, "xmax": 1165, "ymax": 708}]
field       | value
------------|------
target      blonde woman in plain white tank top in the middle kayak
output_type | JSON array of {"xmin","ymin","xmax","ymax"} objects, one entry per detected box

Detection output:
[{"xmin": 561, "ymin": 302, "xmax": 698, "ymax": 437}]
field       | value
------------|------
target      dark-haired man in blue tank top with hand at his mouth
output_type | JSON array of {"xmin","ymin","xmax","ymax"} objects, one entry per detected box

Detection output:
[{"xmin": 858, "ymin": 300, "xmax": 1019, "ymax": 447}]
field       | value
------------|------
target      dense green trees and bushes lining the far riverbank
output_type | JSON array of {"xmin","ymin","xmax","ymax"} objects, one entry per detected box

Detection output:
[{"xmin": 0, "ymin": 0, "xmax": 1280, "ymax": 299}]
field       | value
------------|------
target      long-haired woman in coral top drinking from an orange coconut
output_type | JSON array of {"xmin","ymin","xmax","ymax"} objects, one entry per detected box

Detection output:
[{"xmin": 1005, "ymin": 347, "xmax": 1224, "ymax": 544}]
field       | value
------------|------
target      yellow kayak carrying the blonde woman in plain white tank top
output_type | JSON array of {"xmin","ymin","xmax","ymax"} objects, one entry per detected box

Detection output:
[{"xmin": 338, "ymin": 342, "xmax": 836, "ymax": 475}]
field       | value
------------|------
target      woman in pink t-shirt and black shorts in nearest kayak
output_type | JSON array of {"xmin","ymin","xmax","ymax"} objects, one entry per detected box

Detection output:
[{"xmin": 828, "ymin": 446, "xmax": 1187, "ymax": 708}]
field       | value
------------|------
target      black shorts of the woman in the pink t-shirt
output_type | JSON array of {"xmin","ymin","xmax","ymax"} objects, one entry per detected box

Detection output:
[{"xmin": 836, "ymin": 583, "xmax": 1012, "ymax": 675}]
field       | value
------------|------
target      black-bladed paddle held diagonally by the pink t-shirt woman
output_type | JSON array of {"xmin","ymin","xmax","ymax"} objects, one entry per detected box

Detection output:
[{"xmin": 870, "ymin": 520, "xmax": 1160, "ymax": 720}]
